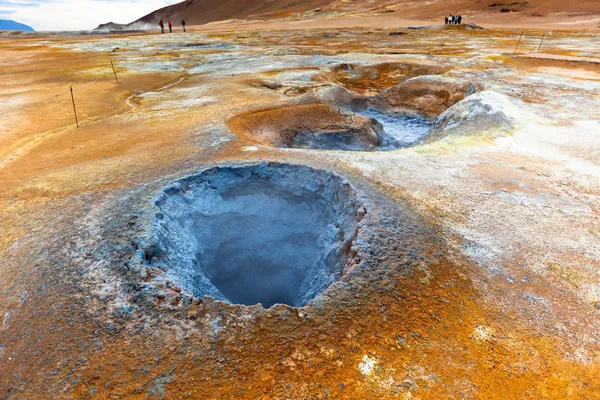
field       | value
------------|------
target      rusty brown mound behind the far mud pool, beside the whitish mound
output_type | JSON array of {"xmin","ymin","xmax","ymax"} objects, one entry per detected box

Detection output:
[{"xmin": 374, "ymin": 75, "xmax": 481, "ymax": 118}]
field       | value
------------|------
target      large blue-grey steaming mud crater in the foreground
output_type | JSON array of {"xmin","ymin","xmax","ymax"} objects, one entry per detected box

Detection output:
[{"xmin": 153, "ymin": 163, "xmax": 366, "ymax": 307}]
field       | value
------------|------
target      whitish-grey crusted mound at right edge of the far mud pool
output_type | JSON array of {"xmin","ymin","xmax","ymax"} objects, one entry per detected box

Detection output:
[{"xmin": 426, "ymin": 90, "xmax": 519, "ymax": 142}]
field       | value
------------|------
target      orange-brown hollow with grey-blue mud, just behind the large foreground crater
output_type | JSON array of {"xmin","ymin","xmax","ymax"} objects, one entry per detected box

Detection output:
[{"xmin": 228, "ymin": 103, "xmax": 383, "ymax": 150}]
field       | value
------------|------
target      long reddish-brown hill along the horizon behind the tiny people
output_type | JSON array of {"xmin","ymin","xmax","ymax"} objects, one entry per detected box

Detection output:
[{"xmin": 96, "ymin": 0, "xmax": 600, "ymax": 31}]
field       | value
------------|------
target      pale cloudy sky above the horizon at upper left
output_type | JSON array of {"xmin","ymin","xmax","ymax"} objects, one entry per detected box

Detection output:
[{"xmin": 0, "ymin": 0, "xmax": 182, "ymax": 31}]
